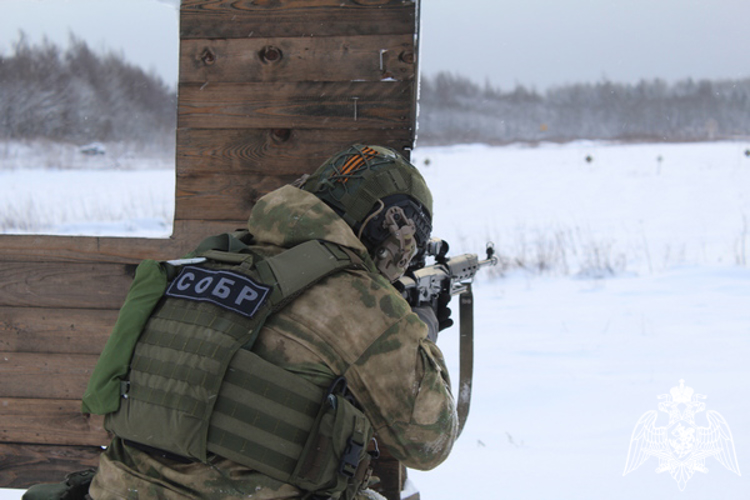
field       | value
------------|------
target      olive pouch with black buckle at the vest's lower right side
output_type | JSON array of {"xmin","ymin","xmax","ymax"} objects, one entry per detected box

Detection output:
[{"xmin": 289, "ymin": 394, "xmax": 373, "ymax": 498}]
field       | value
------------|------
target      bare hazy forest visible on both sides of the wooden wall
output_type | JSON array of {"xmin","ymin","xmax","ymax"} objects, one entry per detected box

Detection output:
[{"xmin": 0, "ymin": 35, "xmax": 750, "ymax": 147}]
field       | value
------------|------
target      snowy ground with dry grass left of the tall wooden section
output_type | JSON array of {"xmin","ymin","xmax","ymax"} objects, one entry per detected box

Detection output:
[{"xmin": 0, "ymin": 141, "xmax": 175, "ymax": 238}]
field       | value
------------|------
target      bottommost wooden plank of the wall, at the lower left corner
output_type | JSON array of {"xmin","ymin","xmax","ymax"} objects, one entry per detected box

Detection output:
[{"xmin": 0, "ymin": 443, "xmax": 102, "ymax": 488}]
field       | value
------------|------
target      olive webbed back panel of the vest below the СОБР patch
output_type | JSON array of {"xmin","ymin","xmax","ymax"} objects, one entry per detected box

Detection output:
[{"xmin": 110, "ymin": 297, "xmax": 270, "ymax": 462}]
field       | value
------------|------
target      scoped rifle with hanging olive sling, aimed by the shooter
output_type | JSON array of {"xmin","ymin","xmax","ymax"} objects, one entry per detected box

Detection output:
[{"xmin": 394, "ymin": 239, "xmax": 498, "ymax": 433}]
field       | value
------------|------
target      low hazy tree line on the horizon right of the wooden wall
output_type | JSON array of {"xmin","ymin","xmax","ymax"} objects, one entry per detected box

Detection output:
[{"xmin": 419, "ymin": 73, "xmax": 750, "ymax": 144}]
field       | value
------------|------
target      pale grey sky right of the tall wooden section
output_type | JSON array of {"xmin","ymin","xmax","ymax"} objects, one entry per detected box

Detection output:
[{"xmin": 421, "ymin": 0, "xmax": 750, "ymax": 90}]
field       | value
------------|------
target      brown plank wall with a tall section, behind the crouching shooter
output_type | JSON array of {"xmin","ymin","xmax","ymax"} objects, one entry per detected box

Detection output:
[{"xmin": 0, "ymin": 0, "xmax": 417, "ymax": 496}]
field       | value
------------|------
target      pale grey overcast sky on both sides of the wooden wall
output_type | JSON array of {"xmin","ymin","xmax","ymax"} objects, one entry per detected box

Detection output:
[{"xmin": 0, "ymin": 0, "xmax": 750, "ymax": 90}]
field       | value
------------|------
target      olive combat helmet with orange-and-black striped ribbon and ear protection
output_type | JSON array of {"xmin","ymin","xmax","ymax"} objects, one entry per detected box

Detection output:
[{"xmin": 301, "ymin": 144, "xmax": 432, "ymax": 281}]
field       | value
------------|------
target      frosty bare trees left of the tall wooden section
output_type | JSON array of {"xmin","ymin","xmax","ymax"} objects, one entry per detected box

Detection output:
[{"xmin": 0, "ymin": 34, "xmax": 177, "ymax": 147}]
